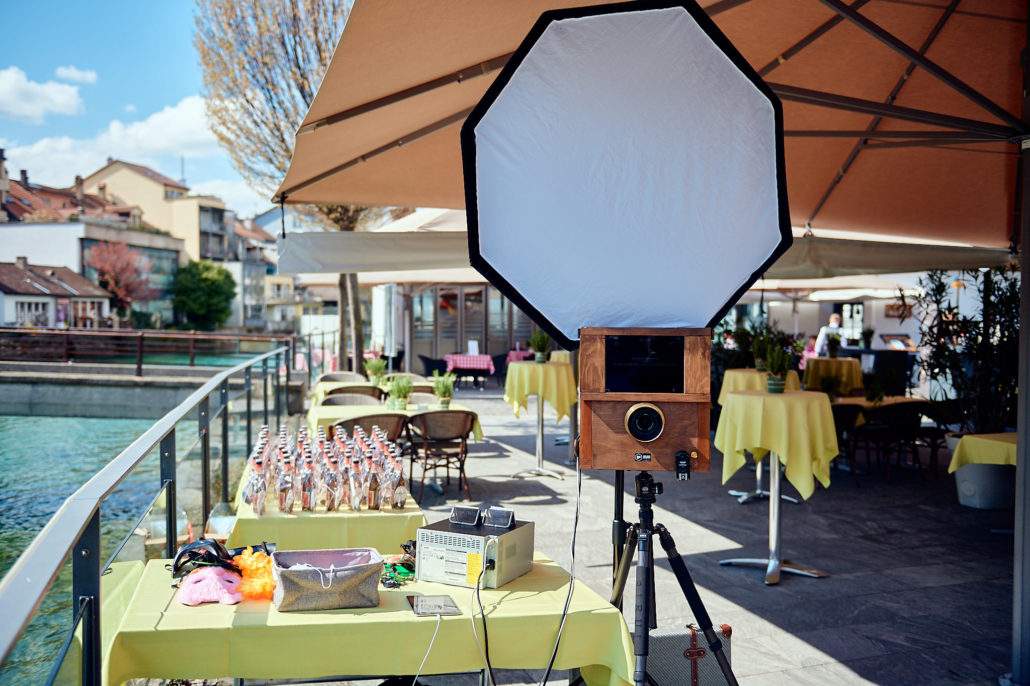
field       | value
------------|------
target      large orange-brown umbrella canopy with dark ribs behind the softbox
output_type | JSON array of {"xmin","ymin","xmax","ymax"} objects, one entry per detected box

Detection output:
[{"xmin": 278, "ymin": 0, "xmax": 1027, "ymax": 247}]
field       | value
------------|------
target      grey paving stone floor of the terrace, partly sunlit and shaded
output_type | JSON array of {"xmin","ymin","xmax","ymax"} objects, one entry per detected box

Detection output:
[{"xmin": 170, "ymin": 381, "xmax": 1012, "ymax": 686}]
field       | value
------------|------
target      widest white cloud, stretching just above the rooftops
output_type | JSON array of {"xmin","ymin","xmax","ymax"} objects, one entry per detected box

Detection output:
[{"xmin": 6, "ymin": 94, "xmax": 220, "ymax": 186}]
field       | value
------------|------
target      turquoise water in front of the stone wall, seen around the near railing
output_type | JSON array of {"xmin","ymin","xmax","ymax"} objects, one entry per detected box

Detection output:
[{"xmin": 0, "ymin": 416, "xmax": 160, "ymax": 686}]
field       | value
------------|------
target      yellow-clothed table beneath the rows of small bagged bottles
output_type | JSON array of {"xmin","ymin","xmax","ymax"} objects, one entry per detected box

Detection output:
[{"xmin": 227, "ymin": 466, "xmax": 425, "ymax": 554}]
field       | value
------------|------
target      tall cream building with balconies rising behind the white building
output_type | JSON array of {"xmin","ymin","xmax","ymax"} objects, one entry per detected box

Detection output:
[{"xmin": 83, "ymin": 158, "xmax": 229, "ymax": 261}]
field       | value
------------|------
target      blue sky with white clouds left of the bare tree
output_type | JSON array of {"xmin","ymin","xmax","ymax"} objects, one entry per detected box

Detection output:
[{"xmin": 0, "ymin": 0, "xmax": 271, "ymax": 216}]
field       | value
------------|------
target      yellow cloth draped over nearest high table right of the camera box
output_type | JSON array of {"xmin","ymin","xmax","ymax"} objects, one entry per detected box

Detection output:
[{"xmin": 715, "ymin": 390, "xmax": 837, "ymax": 500}]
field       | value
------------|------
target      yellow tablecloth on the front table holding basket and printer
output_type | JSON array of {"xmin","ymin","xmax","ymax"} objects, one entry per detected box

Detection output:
[{"xmin": 104, "ymin": 554, "xmax": 633, "ymax": 686}]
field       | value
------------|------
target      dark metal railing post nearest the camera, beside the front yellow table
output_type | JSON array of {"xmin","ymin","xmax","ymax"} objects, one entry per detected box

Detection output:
[{"xmin": 71, "ymin": 507, "xmax": 101, "ymax": 686}]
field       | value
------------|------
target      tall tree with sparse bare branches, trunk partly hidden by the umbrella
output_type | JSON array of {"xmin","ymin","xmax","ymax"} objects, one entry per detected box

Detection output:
[{"xmin": 194, "ymin": 0, "xmax": 370, "ymax": 371}]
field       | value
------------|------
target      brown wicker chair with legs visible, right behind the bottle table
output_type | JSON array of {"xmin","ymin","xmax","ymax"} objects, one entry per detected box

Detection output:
[{"xmin": 408, "ymin": 410, "xmax": 476, "ymax": 502}]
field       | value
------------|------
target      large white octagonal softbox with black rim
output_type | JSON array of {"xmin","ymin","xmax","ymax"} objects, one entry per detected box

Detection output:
[{"xmin": 461, "ymin": 2, "xmax": 791, "ymax": 348}]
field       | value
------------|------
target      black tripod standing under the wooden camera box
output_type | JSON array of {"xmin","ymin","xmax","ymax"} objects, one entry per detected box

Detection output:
[{"xmin": 612, "ymin": 472, "xmax": 736, "ymax": 686}]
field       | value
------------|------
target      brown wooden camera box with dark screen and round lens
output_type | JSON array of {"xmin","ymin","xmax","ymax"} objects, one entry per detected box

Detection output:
[{"xmin": 579, "ymin": 328, "xmax": 712, "ymax": 469}]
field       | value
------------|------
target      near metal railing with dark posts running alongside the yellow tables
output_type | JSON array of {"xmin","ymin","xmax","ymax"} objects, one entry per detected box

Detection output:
[{"xmin": 0, "ymin": 346, "xmax": 291, "ymax": 686}]
